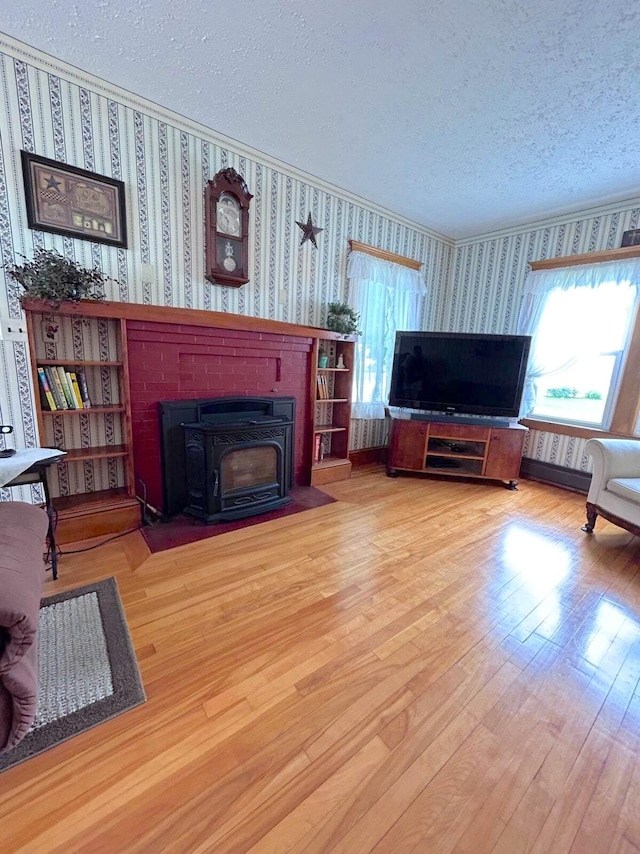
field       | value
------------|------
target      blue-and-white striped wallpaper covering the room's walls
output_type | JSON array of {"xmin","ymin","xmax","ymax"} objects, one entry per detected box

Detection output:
[{"xmin": 0, "ymin": 36, "xmax": 640, "ymax": 500}]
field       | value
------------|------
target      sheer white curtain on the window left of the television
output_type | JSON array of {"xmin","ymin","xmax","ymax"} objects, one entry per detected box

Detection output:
[{"xmin": 347, "ymin": 252, "xmax": 426, "ymax": 418}]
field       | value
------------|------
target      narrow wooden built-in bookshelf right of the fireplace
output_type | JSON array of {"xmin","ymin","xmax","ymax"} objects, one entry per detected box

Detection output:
[{"xmin": 311, "ymin": 333, "xmax": 355, "ymax": 486}]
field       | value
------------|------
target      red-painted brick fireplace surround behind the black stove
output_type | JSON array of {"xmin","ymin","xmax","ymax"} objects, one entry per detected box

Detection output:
[{"xmin": 126, "ymin": 308, "xmax": 313, "ymax": 507}]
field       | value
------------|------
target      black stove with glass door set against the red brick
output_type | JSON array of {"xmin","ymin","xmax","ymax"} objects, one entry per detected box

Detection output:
[{"xmin": 160, "ymin": 397, "xmax": 295, "ymax": 522}]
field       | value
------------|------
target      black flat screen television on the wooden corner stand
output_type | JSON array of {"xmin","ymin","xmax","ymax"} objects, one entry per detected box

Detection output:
[{"xmin": 389, "ymin": 332, "xmax": 531, "ymax": 418}]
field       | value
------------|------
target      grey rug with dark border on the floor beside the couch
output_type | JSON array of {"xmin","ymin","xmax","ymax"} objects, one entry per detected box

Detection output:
[{"xmin": 0, "ymin": 578, "xmax": 146, "ymax": 771}]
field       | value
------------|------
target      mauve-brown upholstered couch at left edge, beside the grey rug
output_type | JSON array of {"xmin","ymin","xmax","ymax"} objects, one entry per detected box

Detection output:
[{"xmin": 0, "ymin": 501, "xmax": 49, "ymax": 753}]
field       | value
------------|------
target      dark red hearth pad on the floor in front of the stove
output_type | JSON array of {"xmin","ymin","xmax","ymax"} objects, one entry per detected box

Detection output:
[{"xmin": 142, "ymin": 486, "xmax": 336, "ymax": 553}]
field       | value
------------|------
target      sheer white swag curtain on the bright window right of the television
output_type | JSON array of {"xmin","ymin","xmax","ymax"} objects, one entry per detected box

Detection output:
[{"xmin": 517, "ymin": 258, "xmax": 640, "ymax": 417}]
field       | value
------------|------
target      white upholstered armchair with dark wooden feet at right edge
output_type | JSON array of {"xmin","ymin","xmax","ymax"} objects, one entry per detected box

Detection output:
[{"xmin": 582, "ymin": 439, "xmax": 640, "ymax": 536}]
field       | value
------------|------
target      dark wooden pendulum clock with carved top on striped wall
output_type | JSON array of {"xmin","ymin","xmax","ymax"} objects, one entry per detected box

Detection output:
[{"xmin": 204, "ymin": 166, "xmax": 253, "ymax": 288}]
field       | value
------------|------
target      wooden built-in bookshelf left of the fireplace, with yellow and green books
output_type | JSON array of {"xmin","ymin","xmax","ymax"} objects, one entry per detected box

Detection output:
[{"xmin": 25, "ymin": 303, "xmax": 140, "ymax": 542}]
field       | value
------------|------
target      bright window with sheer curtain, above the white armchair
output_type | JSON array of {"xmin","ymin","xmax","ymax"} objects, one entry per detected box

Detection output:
[{"xmin": 518, "ymin": 259, "xmax": 640, "ymax": 429}]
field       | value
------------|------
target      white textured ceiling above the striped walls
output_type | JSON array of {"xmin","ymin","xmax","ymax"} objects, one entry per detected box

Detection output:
[{"xmin": 0, "ymin": 0, "xmax": 640, "ymax": 238}]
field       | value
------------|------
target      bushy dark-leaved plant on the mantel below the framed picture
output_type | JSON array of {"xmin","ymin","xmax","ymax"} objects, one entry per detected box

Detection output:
[{"xmin": 4, "ymin": 249, "xmax": 107, "ymax": 307}]
